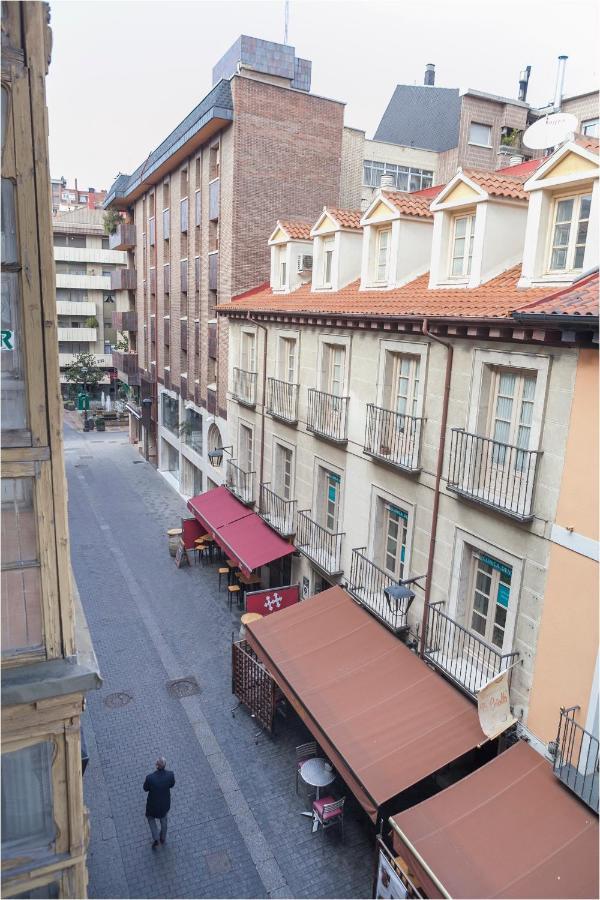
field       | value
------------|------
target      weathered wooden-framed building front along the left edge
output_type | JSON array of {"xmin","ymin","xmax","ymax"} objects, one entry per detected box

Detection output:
[{"xmin": 0, "ymin": 2, "xmax": 100, "ymax": 898}]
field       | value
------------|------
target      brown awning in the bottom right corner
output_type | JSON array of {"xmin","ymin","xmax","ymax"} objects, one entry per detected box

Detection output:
[{"xmin": 390, "ymin": 741, "xmax": 598, "ymax": 898}]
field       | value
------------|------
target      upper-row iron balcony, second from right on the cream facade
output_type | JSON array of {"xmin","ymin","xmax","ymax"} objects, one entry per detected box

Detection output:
[{"xmin": 363, "ymin": 403, "xmax": 425, "ymax": 472}]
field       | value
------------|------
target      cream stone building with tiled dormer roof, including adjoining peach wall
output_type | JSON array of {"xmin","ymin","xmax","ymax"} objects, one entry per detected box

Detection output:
[{"xmin": 218, "ymin": 138, "xmax": 600, "ymax": 811}]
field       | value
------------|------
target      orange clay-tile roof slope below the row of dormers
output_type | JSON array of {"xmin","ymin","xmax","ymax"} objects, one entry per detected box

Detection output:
[{"xmin": 219, "ymin": 266, "xmax": 548, "ymax": 319}]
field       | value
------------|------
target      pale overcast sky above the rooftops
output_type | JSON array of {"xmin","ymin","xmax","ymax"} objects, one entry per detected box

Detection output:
[{"xmin": 46, "ymin": 0, "xmax": 599, "ymax": 189}]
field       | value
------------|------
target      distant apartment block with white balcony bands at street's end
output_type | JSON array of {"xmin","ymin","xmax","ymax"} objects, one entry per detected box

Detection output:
[{"xmin": 52, "ymin": 207, "xmax": 129, "ymax": 391}]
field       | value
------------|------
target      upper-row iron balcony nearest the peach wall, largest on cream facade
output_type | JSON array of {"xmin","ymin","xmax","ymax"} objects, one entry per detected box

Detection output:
[{"xmin": 448, "ymin": 428, "xmax": 541, "ymax": 522}]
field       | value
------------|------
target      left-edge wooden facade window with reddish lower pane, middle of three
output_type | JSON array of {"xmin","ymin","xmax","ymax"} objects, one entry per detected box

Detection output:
[{"xmin": 1, "ymin": 478, "xmax": 42, "ymax": 657}]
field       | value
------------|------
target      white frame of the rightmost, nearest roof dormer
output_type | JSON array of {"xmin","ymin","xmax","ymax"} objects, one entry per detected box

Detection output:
[{"xmin": 519, "ymin": 141, "xmax": 600, "ymax": 287}]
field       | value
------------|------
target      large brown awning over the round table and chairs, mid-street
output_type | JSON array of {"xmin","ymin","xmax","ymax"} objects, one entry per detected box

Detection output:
[{"xmin": 246, "ymin": 587, "xmax": 486, "ymax": 820}]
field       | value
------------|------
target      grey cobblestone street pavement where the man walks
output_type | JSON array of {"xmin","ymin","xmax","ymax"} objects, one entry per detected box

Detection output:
[{"xmin": 65, "ymin": 426, "xmax": 373, "ymax": 897}]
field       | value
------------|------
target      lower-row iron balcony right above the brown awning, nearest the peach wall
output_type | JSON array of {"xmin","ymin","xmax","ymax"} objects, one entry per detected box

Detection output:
[{"xmin": 424, "ymin": 601, "xmax": 519, "ymax": 697}]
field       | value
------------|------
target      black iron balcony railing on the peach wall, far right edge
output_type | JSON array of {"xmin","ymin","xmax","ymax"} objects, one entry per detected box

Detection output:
[{"xmin": 553, "ymin": 706, "xmax": 598, "ymax": 813}]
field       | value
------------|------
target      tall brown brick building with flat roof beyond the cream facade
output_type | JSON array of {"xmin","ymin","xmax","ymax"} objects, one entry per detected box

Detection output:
[{"xmin": 105, "ymin": 36, "xmax": 362, "ymax": 496}]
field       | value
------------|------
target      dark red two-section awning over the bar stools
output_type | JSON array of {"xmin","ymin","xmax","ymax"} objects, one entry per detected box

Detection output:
[{"xmin": 188, "ymin": 487, "xmax": 294, "ymax": 575}]
